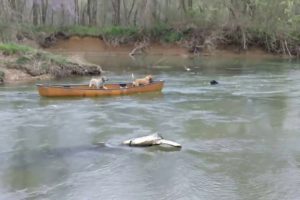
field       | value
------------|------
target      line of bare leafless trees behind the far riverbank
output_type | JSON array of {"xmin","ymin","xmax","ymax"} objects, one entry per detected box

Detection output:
[{"xmin": 0, "ymin": 0, "xmax": 300, "ymax": 54}]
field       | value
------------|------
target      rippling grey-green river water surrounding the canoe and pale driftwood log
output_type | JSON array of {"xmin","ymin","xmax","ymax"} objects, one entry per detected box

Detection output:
[{"xmin": 0, "ymin": 53, "xmax": 300, "ymax": 200}]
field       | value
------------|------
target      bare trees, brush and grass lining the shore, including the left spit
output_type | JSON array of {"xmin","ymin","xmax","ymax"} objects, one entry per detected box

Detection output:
[{"xmin": 0, "ymin": 0, "xmax": 300, "ymax": 82}]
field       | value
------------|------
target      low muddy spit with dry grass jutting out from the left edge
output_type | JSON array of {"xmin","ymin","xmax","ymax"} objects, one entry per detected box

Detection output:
[{"xmin": 0, "ymin": 49, "xmax": 102, "ymax": 84}]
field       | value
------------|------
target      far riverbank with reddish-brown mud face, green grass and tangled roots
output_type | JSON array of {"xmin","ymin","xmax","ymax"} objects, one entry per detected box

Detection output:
[{"xmin": 29, "ymin": 24, "xmax": 300, "ymax": 57}]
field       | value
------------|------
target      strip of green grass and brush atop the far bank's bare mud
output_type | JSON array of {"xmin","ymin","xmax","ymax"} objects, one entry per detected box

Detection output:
[{"xmin": 15, "ymin": 23, "xmax": 300, "ymax": 56}]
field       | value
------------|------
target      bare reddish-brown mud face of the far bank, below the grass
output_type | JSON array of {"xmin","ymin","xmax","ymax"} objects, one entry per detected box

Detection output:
[{"xmin": 46, "ymin": 36, "xmax": 282, "ymax": 58}]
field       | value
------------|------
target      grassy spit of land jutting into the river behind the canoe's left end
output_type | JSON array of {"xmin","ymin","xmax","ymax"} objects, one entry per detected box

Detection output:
[{"xmin": 0, "ymin": 43, "xmax": 101, "ymax": 83}]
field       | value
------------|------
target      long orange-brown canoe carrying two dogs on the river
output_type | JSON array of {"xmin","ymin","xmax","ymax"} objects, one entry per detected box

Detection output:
[{"xmin": 37, "ymin": 81, "xmax": 164, "ymax": 97}]
